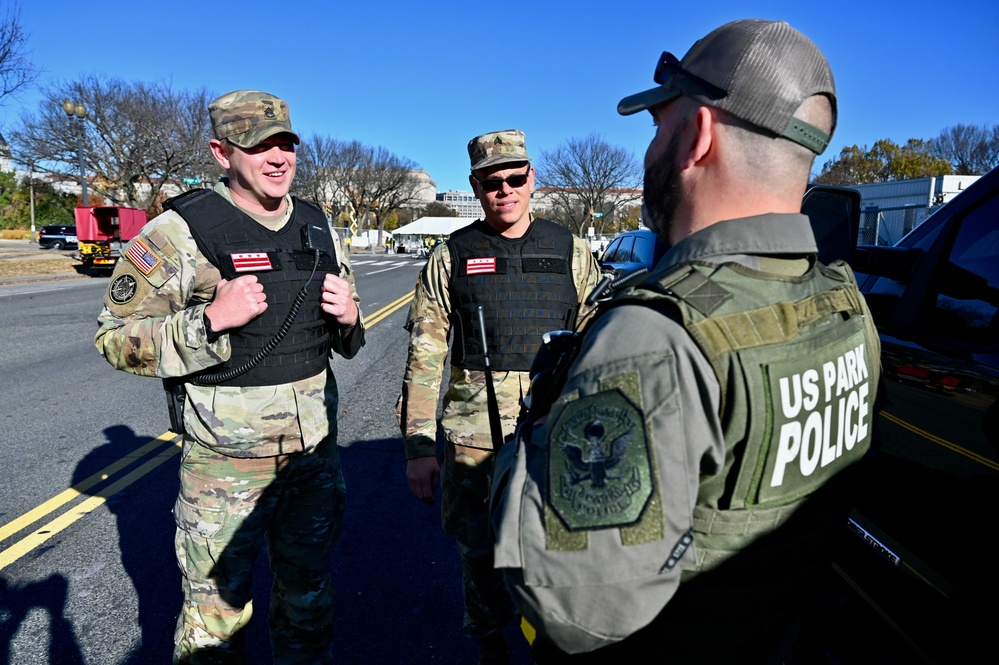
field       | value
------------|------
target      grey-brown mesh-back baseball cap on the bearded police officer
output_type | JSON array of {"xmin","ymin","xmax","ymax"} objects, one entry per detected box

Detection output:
[{"xmin": 617, "ymin": 19, "xmax": 836, "ymax": 154}]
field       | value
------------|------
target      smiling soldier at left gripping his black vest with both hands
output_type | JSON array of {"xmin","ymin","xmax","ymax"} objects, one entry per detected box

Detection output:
[{"xmin": 96, "ymin": 90, "xmax": 364, "ymax": 665}]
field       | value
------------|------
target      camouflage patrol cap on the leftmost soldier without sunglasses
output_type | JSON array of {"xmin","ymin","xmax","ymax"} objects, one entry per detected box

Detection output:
[{"xmin": 208, "ymin": 90, "xmax": 302, "ymax": 148}]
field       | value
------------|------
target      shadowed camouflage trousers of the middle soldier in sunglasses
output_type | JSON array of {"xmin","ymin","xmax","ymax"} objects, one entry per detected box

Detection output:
[{"xmin": 441, "ymin": 443, "xmax": 513, "ymax": 638}]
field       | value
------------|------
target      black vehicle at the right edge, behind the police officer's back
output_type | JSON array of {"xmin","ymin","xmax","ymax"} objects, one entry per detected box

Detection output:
[{"xmin": 812, "ymin": 169, "xmax": 999, "ymax": 663}]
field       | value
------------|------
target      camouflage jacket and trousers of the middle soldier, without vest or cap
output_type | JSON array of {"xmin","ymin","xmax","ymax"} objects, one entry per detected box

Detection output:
[{"xmin": 397, "ymin": 217, "xmax": 600, "ymax": 637}]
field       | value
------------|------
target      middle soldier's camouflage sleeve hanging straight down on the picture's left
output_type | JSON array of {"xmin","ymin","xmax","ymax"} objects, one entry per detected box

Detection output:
[{"xmin": 397, "ymin": 243, "xmax": 451, "ymax": 459}]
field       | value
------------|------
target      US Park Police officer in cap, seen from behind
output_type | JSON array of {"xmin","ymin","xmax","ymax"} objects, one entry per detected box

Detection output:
[{"xmin": 492, "ymin": 20, "xmax": 880, "ymax": 663}]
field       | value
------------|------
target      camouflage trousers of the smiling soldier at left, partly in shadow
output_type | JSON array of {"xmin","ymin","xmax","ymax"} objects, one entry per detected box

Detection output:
[{"xmin": 174, "ymin": 433, "xmax": 346, "ymax": 665}]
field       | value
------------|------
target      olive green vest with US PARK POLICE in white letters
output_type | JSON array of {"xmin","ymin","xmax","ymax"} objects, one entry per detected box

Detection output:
[{"xmin": 616, "ymin": 258, "xmax": 880, "ymax": 651}]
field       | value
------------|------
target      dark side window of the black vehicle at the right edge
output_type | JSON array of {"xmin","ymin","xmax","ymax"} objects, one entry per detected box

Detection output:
[{"xmin": 923, "ymin": 191, "xmax": 999, "ymax": 353}]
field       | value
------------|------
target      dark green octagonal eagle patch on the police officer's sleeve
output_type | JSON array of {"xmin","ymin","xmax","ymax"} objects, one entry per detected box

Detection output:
[{"xmin": 548, "ymin": 389, "xmax": 653, "ymax": 531}]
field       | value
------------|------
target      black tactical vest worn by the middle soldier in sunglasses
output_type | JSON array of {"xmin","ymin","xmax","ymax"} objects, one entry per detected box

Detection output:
[{"xmin": 447, "ymin": 219, "xmax": 578, "ymax": 371}]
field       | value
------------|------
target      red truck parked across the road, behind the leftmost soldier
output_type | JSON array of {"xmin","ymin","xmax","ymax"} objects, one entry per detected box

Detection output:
[{"xmin": 75, "ymin": 206, "xmax": 146, "ymax": 271}]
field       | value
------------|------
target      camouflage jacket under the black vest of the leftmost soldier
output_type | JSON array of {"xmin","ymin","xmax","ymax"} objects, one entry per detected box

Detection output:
[{"xmin": 95, "ymin": 183, "xmax": 364, "ymax": 457}]
